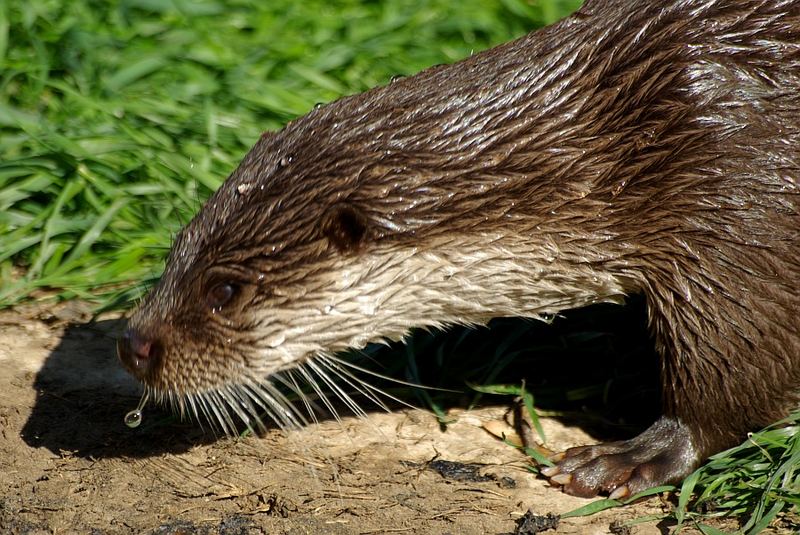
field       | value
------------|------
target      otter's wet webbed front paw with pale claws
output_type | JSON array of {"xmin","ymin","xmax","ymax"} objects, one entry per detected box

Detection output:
[{"xmin": 541, "ymin": 417, "xmax": 700, "ymax": 499}]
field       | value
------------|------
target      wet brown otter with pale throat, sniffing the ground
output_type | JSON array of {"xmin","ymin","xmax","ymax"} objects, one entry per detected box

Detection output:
[{"xmin": 118, "ymin": 0, "xmax": 800, "ymax": 498}]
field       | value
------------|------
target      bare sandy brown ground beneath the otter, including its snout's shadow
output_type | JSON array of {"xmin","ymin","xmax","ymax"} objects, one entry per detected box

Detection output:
[{"xmin": 0, "ymin": 304, "xmax": 788, "ymax": 534}]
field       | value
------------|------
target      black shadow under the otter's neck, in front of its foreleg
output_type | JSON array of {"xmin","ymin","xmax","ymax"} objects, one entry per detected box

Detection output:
[{"xmin": 350, "ymin": 297, "xmax": 661, "ymax": 440}]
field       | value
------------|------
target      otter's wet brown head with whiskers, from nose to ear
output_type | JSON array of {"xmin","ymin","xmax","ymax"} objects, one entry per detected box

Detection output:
[{"xmin": 118, "ymin": 92, "xmax": 434, "ymax": 430}]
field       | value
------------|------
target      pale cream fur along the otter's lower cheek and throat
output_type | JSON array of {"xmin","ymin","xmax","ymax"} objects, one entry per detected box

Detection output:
[{"xmin": 250, "ymin": 235, "xmax": 628, "ymax": 376}]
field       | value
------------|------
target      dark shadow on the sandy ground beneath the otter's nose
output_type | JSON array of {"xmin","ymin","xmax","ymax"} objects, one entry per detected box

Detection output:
[{"xmin": 21, "ymin": 320, "xmax": 215, "ymax": 458}]
